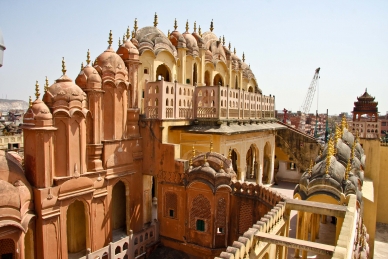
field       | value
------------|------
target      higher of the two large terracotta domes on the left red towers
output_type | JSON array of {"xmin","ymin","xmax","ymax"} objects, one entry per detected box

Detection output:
[{"xmin": 94, "ymin": 31, "xmax": 128, "ymax": 81}]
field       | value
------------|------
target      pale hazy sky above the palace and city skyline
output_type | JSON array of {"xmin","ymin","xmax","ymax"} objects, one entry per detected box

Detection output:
[{"xmin": 0, "ymin": 0, "xmax": 388, "ymax": 114}]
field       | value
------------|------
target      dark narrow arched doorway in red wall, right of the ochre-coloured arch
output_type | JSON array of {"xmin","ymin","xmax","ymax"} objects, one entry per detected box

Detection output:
[{"xmin": 112, "ymin": 181, "xmax": 127, "ymax": 242}]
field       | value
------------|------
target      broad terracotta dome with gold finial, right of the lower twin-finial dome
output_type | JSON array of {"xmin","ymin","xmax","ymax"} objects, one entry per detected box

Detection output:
[{"xmin": 43, "ymin": 59, "xmax": 87, "ymax": 114}]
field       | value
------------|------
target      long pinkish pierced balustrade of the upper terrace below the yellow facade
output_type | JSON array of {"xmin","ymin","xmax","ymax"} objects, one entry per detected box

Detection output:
[{"xmin": 144, "ymin": 80, "xmax": 275, "ymax": 120}]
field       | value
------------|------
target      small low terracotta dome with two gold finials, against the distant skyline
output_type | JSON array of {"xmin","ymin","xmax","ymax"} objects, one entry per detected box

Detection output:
[{"xmin": 23, "ymin": 80, "xmax": 53, "ymax": 126}]
